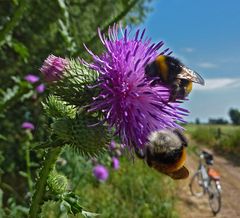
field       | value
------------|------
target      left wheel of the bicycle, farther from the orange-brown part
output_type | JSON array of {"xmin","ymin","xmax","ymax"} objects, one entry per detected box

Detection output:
[{"xmin": 189, "ymin": 171, "xmax": 204, "ymax": 197}]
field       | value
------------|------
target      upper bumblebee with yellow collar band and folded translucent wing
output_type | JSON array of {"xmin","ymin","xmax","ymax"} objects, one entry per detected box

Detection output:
[{"xmin": 145, "ymin": 55, "xmax": 204, "ymax": 102}]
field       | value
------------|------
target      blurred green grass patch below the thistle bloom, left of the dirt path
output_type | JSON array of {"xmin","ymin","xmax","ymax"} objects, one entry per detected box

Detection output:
[{"xmin": 43, "ymin": 158, "xmax": 178, "ymax": 218}]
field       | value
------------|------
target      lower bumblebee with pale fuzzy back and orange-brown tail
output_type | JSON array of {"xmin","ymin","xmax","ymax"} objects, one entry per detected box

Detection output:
[{"xmin": 135, "ymin": 129, "xmax": 189, "ymax": 180}]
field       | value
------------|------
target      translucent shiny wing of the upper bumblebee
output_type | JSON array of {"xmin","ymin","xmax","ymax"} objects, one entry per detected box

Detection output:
[{"xmin": 177, "ymin": 66, "xmax": 205, "ymax": 85}]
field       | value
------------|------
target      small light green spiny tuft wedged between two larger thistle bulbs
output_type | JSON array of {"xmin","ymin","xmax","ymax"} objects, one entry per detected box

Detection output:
[{"xmin": 42, "ymin": 95, "xmax": 76, "ymax": 118}]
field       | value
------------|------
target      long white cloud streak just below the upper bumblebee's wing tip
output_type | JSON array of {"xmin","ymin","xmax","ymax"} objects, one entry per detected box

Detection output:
[{"xmin": 193, "ymin": 78, "xmax": 240, "ymax": 91}]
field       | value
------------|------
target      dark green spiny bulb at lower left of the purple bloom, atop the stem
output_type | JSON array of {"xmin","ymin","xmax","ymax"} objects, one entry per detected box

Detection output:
[{"xmin": 52, "ymin": 112, "xmax": 110, "ymax": 157}]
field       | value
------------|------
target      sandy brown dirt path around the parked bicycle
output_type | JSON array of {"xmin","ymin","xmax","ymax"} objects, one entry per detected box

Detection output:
[{"xmin": 177, "ymin": 147, "xmax": 240, "ymax": 218}]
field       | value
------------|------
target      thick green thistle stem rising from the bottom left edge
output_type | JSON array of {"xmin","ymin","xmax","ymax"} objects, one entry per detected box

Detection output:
[{"xmin": 29, "ymin": 147, "xmax": 62, "ymax": 218}]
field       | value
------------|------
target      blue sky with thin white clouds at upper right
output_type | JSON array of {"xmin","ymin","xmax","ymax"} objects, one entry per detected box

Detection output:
[{"xmin": 141, "ymin": 0, "xmax": 240, "ymax": 121}]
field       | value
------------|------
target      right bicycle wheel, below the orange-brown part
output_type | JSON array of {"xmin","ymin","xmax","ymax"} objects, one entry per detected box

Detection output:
[{"xmin": 208, "ymin": 180, "xmax": 221, "ymax": 215}]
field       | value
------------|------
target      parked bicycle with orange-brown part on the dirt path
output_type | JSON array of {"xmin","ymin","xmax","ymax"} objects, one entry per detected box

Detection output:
[{"xmin": 189, "ymin": 151, "xmax": 222, "ymax": 215}]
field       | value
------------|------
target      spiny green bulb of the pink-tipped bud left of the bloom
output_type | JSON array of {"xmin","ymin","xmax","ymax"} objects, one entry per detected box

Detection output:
[{"xmin": 50, "ymin": 59, "xmax": 99, "ymax": 107}]
